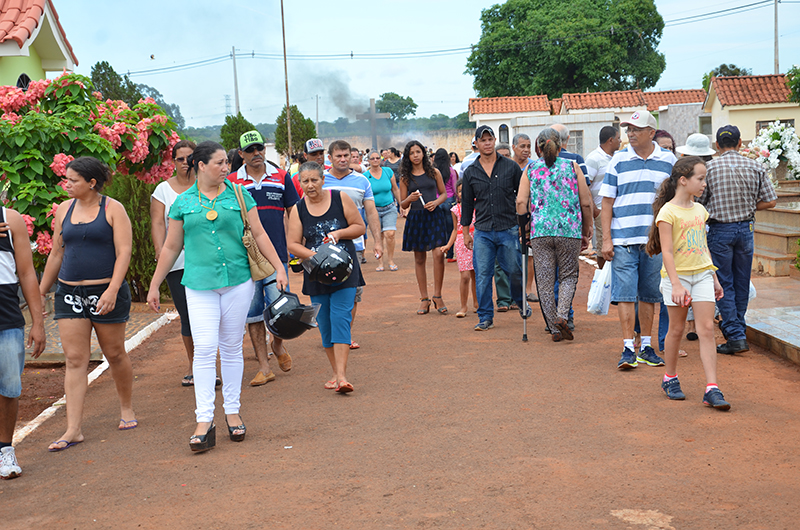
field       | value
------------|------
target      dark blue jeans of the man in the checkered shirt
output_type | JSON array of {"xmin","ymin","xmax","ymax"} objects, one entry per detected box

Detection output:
[{"xmin": 708, "ymin": 221, "xmax": 753, "ymax": 340}]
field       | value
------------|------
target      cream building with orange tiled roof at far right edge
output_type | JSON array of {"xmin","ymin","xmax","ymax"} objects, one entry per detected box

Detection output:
[{"xmin": 703, "ymin": 74, "xmax": 800, "ymax": 144}]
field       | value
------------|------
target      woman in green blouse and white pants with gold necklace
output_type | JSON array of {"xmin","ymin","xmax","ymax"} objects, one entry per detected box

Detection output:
[{"xmin": 147, "ymin": 142, "xmax": 288, "ymax": 451}]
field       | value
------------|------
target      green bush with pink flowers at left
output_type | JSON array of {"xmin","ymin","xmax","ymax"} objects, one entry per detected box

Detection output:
[{"xmin": 0, "ymin": 73, "xmax": 180, "ymax": 270}]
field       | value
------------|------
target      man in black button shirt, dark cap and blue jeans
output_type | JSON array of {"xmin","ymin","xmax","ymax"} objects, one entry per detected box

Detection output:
[{"xmin": 461, "ymin": 125, "xmax": 530, "ymax": 331}]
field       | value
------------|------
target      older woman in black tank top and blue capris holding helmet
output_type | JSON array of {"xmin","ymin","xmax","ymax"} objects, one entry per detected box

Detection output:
[{"xmin": 287, "ymin": 162, "xmax": 366, "ymax": 393}]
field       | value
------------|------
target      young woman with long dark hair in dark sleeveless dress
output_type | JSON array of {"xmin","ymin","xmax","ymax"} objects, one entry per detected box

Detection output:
[{"xmin": 400, "ymin": 140, "xmax": 452, "ymax": 315}]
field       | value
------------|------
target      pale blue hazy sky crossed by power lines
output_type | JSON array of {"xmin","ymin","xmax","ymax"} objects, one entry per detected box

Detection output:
[{"xmin": 53, "ymin": 0, "xmax": 800, "ymax": 127}]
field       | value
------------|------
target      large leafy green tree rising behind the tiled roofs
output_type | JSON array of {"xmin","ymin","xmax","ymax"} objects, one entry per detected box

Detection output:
[{"xmin": 467, "ymin": 0, "xmax": 666, "ymax": 97}]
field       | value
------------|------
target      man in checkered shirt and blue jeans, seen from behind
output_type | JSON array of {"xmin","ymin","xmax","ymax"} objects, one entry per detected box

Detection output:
[{"xmin": 699, "ymin": 125, "xmax": 778, "ymax": 355}]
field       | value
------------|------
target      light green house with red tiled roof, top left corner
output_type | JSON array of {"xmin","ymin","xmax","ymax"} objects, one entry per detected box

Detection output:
[{"xmin": 0, "ymin": 0, "xmax": 78, "ymax": 88}]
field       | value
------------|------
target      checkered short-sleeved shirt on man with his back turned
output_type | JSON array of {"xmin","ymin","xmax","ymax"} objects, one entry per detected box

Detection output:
[{"xmin": 698, "ymin": 151, "xmax": 778, "ymax": 223}]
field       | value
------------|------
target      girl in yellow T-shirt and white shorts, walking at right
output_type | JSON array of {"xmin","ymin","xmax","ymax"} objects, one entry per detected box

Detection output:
[{"xmin": 647, "ymin": 156, "xmax": 731, "ymax": 410}]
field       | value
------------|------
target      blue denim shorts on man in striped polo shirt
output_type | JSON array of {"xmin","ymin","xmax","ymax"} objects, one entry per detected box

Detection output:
[{"xmin": 611, "ymin": 245, "xmax": 662, "ymax": 304}]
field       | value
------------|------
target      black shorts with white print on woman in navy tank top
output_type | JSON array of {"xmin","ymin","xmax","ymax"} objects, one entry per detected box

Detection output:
[{"xmin": 53, "ymin": 280, "xmax": 131, "ymax": 324}]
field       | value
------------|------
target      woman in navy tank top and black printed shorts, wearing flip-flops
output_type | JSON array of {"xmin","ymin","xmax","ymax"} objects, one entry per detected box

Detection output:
[{"xmin": 39, "ymin": 157, "xmax": 138, "ymax": 451}]
